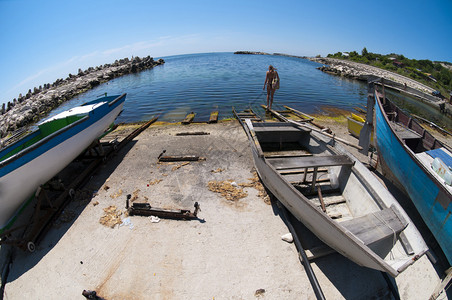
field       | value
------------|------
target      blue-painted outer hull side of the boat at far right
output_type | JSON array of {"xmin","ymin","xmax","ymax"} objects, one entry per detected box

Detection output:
[{"xmin": 375, "ymin": 94, "xmax": 452, "ymax": 264}]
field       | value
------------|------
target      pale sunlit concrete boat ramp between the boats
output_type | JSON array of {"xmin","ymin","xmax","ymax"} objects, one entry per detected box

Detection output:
[{"xmin": 1, "ymin": 121, "xmax": 444, "ymax": 299}]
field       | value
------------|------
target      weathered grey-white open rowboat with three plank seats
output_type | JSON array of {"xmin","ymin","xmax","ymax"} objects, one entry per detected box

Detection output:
[{"xmin": 236, "ymin": 109, "xmax": 428, "ymax": 277}]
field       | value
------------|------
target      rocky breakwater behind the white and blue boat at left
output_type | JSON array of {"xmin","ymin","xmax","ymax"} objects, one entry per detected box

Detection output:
[{"xmin": 0, "ymin": 56, "xmax": 165, "ymax": 138}]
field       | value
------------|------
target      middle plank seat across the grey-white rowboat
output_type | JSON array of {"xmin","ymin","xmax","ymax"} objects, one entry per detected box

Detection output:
[{"xmin": 268, "ymin": 155, "xmax": 354, "ymax": 170}]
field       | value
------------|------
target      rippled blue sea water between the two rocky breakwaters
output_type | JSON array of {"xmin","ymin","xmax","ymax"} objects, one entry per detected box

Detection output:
[{"xmin": 47, "ymin": 53, "xmax": 450, "ymax": 130}]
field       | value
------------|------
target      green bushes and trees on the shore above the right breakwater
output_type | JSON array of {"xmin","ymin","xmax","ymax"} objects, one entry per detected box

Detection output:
[{"xmin": 328, "ymin": 47, "xmax": 452, "ymax": 98}]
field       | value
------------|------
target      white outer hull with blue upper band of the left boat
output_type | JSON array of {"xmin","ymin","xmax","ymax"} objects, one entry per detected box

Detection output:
[{"xmin": 0, "ymin": 95, "xmax": 125, "ymax": 229}]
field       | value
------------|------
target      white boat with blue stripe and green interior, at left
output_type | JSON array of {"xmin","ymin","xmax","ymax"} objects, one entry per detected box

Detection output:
[{"xmin": 0, "ymin": 94, "xmax": 126, "ymax": 229}]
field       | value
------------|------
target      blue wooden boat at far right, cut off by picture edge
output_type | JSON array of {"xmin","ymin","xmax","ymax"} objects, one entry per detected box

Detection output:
[{"xmin": 375, "ymin": 93, "xmax": 452, "ymax": 264}]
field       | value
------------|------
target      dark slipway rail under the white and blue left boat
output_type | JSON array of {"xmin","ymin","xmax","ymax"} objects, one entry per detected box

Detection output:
[{"xmin": 0, "ymin": 118, "xmax": 157, "ymax": 252}]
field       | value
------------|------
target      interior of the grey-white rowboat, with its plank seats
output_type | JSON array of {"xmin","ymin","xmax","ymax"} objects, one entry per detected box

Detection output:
[{"xmin": 253, "ymin": 122, "xmax": 412, "ymax": 258}]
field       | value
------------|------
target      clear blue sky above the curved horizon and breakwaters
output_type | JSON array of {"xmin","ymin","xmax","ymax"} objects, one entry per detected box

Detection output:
[{"xmin": 0, "ymin": 0, "xmax": 452, "ymax": 103}]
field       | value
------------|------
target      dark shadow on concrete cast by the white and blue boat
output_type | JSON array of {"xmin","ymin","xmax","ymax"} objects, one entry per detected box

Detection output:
[{"xmin": 0, "ymin": 141, "xmax": 136, "ymax": 284}]
